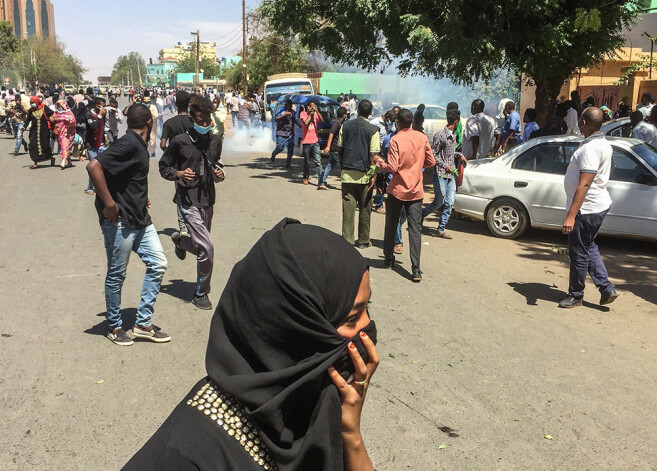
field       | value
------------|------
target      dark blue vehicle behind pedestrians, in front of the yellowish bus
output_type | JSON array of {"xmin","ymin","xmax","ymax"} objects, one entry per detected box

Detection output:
[{"xmin": 272, "ymin": 95, "xmax": 340, "ymax": 151}]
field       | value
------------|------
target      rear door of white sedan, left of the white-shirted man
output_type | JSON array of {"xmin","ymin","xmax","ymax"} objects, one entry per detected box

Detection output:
[{"xmin": 502, "ymin": 142, "xmax": 577, "ymax": 227}]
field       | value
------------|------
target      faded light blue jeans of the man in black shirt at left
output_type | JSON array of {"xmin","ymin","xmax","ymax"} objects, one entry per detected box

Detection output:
[{"xmin": 101, "ymin": 220, "xmax": 167, "ymax": 330}]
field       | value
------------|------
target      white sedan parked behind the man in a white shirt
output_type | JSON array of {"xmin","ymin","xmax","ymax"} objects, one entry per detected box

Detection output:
[{"xmin": 454, "ymin": 136, "xmax": 657, "ymax": 240}]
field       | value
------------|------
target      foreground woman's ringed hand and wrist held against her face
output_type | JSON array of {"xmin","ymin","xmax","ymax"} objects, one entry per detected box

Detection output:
[{"xmin": 329, "ymin": 332, "xmax": 379, "ymax": 438}]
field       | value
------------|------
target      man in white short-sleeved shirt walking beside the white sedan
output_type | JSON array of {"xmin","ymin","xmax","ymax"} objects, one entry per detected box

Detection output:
[{"xmin": 559, "ymin": 106, "xmax": 618, "ymax": 308}]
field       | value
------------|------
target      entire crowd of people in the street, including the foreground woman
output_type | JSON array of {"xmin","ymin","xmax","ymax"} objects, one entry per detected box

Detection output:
[{"xmin": 0, "ymin": 79, "xmax": 624, "ymax": 470}]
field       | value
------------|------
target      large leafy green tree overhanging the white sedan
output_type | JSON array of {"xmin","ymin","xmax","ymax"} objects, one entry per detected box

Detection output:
[{"xmin": 261, "ymin": 0, "xmax": 645, "ymax": 122}]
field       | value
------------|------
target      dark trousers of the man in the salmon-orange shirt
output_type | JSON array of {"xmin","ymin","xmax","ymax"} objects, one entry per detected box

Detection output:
[{"xmin": 383, "ymin": 194, "xmax": 422, "ymax": 269}]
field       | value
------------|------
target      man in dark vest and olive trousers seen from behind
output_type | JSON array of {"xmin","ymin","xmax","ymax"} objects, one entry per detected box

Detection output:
[{"xmin": 338, "ymin": 100, "xmax": 381, "ymax": 248}]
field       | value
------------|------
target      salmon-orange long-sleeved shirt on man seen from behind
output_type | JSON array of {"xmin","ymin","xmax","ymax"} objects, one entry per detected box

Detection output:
[{"xmin": 376, "ymin": 128, "xmax": 436, "ymax": 201}]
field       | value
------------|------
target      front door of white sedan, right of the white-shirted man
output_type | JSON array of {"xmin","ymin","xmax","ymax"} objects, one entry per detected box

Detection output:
[{"xmin": 601, "ymin": 146, "xmax": 657, "ymax": 237}]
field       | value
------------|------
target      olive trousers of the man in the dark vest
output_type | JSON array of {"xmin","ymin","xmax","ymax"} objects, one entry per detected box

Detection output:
[{"xmin": 342, "ymin": 182, "xmax": 372, "ymax": 245}]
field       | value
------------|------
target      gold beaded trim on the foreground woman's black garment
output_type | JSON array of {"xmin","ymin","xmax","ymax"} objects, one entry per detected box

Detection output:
[{"xmin": 187, "ymin": 382, "xmax": 278, "ymax": 471}]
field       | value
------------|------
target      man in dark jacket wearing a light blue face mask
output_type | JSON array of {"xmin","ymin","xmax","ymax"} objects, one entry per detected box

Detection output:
[{"xmin": 160, "ymin": 96, "xmax": 224, "ymax": 310}]
